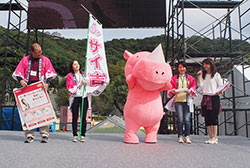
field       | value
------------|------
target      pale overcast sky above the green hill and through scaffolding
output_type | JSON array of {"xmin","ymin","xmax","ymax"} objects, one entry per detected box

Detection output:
[{"xmin": 0, "ymin": 0, "xmax": 250, "ymax": 41}]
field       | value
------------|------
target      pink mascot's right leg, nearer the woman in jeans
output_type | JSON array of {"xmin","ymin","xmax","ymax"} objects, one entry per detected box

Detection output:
[{"xmin": 144, "ymin": 122, "xmax": 161, "ymax": 143}]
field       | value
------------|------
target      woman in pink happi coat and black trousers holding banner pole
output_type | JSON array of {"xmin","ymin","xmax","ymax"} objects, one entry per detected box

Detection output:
[{"xmin": 66, "ymin": 60, "xmax": 88, "ymax": 142}]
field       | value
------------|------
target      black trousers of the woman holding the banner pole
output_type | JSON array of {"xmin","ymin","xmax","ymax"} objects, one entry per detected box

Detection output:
[{"xmin": 71, "ymin": 97, "xmax": 88, "ymax": 136}]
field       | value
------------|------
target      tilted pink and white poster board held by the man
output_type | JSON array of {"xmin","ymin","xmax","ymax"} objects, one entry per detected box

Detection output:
[{"xmin": 13, "ymin": 81, "xmax": 56, "ymax": 130}]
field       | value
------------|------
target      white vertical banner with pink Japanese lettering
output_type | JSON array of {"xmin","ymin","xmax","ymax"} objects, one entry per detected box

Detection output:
[{"xmin": 85, "ymin": 14, "xmax": 110, "ymax": 96}]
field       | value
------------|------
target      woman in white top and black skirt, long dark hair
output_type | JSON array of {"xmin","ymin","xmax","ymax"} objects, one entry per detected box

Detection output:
[{"xmin": 197, "ymin": 58, "xmax": 223, "ymax": 144}]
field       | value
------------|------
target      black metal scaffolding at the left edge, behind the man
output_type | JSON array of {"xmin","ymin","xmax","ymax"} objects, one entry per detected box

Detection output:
[{"xmin": 0, "ymin": 0, "xmax": 27, "ymax": 129}]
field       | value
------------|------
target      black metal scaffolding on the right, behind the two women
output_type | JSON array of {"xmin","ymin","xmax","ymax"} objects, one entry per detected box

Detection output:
[{"xmin": 162, "ymin": 0, "xmax": 250, "ymax": 137}]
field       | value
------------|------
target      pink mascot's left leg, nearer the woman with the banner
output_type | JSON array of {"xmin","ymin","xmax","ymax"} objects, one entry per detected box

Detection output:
[{"xmin": 124, "ymin": 118, "xmax": 140, "ymax": 144}]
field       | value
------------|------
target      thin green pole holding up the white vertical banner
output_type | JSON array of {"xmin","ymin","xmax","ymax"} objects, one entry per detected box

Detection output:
[{"xmin": 79, "ymin": 13, "xmax": 91, "ymax": 139}]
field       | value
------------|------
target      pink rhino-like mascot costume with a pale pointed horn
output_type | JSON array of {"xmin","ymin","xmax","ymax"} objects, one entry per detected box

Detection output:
[{"xmin": 124, "ymin": 45, "xmax": 172, "ymax": 143}]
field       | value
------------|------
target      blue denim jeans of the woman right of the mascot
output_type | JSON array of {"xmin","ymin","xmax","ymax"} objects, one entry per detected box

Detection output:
[{"xmin": 175, "ymin": 102, "xmax": 191, "ymax": 136}]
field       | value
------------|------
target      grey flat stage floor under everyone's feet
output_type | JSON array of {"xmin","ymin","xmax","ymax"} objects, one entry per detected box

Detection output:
[{"xmin": 0, "ymin": 131, "xmax": 250, "ymax": 168}]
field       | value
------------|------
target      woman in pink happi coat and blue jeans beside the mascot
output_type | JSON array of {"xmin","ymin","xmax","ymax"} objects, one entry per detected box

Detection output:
[{"xmin": 168, "ymin": 61, "xmax": 196, "ymax": 144}]
